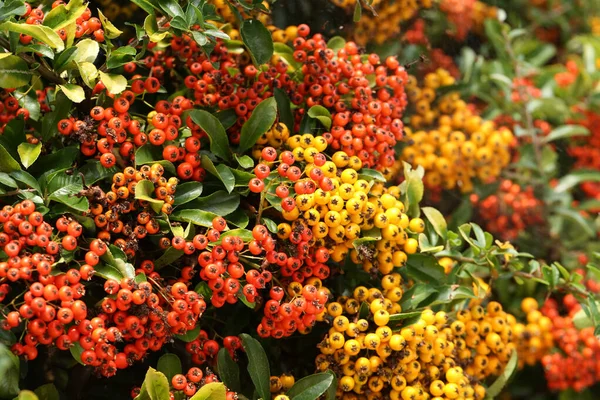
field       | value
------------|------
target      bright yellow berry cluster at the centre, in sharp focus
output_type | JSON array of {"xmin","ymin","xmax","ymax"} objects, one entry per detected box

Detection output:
[{"xmin": 272, "ymin": 133, "xmax": 424, "ymax": 274}]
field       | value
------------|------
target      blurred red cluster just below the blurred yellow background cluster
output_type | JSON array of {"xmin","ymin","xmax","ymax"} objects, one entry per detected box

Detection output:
[{"xmin": 470, "ymin": 180, "xmax": 544, "ymax": 240}]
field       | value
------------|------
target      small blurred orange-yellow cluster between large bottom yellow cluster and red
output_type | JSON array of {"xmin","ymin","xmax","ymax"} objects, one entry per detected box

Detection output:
[{"xmin": 514, "ymin": 297, "xmax": 554, "ymax": 368}]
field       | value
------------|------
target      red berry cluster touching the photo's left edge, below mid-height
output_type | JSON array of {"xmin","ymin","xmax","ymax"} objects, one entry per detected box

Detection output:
[{"xmin": 0, "ymin": 200, "xmax": 89, "ymax": 360}]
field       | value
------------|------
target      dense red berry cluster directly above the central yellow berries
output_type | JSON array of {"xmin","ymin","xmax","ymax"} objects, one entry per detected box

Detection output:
[{"xmin": 291, "ymin": 25, "xmax": 408, "ymax": 169}]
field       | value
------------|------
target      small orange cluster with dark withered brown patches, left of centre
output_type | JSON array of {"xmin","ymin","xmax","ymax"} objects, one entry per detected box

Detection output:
[{"xmin": 83, "ymin": 164, "xmax": 177, "ymax": 257}]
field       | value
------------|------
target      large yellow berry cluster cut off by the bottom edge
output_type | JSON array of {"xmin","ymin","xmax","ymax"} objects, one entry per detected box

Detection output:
[{"xmin": 315, "ymin": 273, "xmax": 516, "ymax": 400}]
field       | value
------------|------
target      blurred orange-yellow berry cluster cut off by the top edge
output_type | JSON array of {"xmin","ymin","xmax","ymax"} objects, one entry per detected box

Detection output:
[{"xmin": 350, "ymin": 0, "xmax": 432, "ymax": 45}]
